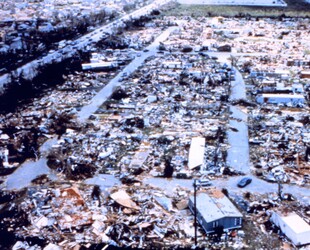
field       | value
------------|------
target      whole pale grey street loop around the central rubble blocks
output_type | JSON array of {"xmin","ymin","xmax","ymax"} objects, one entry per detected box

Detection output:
[{"xmin": 5, "ymin": 41, "xmax": 310, "ymax": 205}]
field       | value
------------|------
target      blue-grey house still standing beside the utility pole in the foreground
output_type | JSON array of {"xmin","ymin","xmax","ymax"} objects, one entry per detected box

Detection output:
[{"xmin": 188, "ymin": 189, "xmax": 242, "ymax": 233}]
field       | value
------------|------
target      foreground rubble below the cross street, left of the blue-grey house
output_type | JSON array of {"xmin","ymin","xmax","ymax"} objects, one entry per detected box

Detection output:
[{"xmin": 1, "ymin": 182, "xmax": 251, "ymax": 249}]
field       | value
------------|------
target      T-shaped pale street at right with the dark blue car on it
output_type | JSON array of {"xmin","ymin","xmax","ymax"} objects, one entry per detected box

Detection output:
[{"xmin": 144, "ymin": 52, "xmax": 310, "ymax": 205}]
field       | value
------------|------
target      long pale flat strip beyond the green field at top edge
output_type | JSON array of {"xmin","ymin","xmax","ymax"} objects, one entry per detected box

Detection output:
[{"xmin": 177, "ymin": 0, "xmax": 286, "ymax": 7}]
